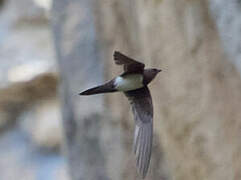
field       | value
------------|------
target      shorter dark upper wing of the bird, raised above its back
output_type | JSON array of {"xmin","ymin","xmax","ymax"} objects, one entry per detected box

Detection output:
[{"xmin": 113, "ymin": 51, "xmax": 145, "ymax": 73}]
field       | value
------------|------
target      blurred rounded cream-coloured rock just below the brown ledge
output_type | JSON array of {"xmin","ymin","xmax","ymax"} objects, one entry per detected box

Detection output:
[{"xmin": 23, "ymin": 97, "xmax": 63, "ymax": 150}]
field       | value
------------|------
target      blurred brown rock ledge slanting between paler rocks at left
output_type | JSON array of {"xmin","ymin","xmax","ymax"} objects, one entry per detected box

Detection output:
[{"xmin": 0, "ymin": 73, "xmax": 58, "ymax": 129}]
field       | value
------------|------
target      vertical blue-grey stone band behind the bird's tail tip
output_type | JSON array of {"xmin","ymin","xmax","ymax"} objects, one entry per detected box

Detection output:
[{"xmin": 52, "ymin": 0, "xmax": 109, "ymax": 180}]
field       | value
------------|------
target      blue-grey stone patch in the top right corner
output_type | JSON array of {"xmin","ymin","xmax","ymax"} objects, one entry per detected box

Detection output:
[{"xmin": 209, "ymin": 0, "xmax": 241, "ymax": 72}]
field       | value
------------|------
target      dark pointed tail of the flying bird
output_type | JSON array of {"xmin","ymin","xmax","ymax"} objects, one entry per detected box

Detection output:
[{"xmin": 79, "ymin": 82, "xmax": 117, "ymax": 95}]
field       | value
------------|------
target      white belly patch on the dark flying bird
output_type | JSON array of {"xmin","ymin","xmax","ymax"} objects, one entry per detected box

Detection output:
[{"xmin": 115, "ymin": 74, "xmax": 143, "ymax": 91}]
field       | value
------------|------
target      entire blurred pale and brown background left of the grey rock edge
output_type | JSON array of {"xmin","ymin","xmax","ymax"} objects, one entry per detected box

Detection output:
[{"xmin": 0, "ymin": 0, "xmax": 68, "ymax": 180}]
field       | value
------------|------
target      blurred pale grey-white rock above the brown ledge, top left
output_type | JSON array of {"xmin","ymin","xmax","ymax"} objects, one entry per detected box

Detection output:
[{"xmin": 0, "ymin": 0, "xmax": 56, "ymax": 87}]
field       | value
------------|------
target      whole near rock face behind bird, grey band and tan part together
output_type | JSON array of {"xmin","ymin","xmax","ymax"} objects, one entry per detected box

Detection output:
[{"xmin": 53, "ymin": 0, "xmax": 241, "ymax": 180}]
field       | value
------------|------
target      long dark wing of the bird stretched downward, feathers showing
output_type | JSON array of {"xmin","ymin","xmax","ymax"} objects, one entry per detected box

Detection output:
[{"xmin": 125, "ymin": 86, "xmax": 153, "ymax": 178}]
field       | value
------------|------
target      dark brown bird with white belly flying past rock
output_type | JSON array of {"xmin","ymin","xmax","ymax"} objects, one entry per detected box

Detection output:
[{"xmin": 79, "ymin": 51, "xmax": 162, "ymax": 179}]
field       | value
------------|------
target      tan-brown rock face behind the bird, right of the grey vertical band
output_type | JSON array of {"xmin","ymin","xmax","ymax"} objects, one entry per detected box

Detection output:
[{"xmin": 94, "ymin": 0, "xmax": 241, "ymax": 180}]
